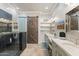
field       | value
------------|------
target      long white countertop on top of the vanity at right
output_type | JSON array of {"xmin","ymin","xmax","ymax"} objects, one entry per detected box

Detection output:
[{"xmin": 45, "ymin": 33, "xmax": 79, "ymax": 56}]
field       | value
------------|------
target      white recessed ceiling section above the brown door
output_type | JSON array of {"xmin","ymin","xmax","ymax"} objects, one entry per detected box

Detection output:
[{"xmin": 9, "ymin": 3, "xmax": 57, "ymax": 14}]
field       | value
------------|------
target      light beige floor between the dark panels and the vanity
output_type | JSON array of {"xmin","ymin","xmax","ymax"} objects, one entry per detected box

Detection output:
[{"xmin": 20, "ymin": 44, "xmax": 48, "ymax": 56}]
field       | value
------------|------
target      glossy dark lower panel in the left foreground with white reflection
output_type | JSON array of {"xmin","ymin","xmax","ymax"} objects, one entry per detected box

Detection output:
[{"xmin": 0, "ymin": 33, "xmax": 19, "ymax": 56}]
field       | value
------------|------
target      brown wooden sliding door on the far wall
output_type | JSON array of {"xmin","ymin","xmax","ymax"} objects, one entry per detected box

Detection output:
[{"xmin": 27, "ymin": 16, "xmax": 38, "ymax": 43}]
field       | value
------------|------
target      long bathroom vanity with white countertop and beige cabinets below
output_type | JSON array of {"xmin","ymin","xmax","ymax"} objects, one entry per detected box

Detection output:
[{"xmin": 45, "ymin": 33, "xmax": 79, "ymax": 56}]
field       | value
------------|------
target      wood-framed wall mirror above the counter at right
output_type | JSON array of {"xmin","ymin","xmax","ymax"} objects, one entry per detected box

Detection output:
[{"xmin": 65, "ymin": 6, "xmax": 79, "ymax": 32}]
